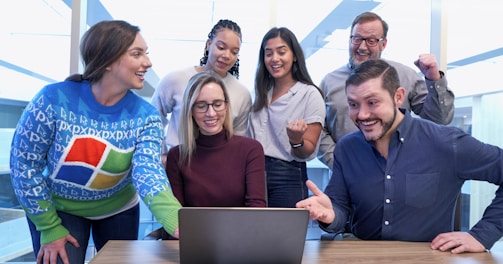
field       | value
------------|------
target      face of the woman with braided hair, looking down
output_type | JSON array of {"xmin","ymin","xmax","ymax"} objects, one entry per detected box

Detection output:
[{"xmin": 206, "ymin": 28, "xmax": 241, "ymax": 77}]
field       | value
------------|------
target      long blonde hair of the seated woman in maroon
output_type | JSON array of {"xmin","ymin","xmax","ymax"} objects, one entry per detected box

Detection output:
[{"xmin": 178, "ymin": 71, "xmax": 234, "ymax": 166}]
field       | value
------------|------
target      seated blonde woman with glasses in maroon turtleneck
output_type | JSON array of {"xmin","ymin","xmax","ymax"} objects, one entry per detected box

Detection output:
[{"xmin": 166, "ymin": 72, "xmax": 267, "ymax": 207}]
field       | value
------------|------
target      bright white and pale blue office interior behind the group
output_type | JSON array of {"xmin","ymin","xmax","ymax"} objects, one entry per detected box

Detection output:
[{"xmin": 0, "ymin": 0, "xmax": 503, "ymax": 262}]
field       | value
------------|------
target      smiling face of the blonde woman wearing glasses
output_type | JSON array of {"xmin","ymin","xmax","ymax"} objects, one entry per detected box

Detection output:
[{"xmin": 192, "ymin": 82, "xmax": 227, "ymax": 136}]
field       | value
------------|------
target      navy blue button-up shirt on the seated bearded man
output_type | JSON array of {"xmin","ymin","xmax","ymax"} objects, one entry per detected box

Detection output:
[{"xmin": 321, "ymin": 110, "xmax": 503, "ymax": 248}]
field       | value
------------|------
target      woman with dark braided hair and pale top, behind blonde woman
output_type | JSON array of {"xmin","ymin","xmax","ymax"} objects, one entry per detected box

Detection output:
[{"xmin": 152, "ymin": 19, "xmax": 251, "ymax": 163}]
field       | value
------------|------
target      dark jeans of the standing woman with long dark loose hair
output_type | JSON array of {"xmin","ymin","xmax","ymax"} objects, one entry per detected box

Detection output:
[{"xmin": 265, "ymin": 156, "xmax": 308, "ymax": 208}]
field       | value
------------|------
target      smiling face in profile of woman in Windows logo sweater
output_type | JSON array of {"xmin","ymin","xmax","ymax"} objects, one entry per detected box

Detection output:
[{"xmin": 108, "ymin": 33, "xmax": 152, "ymax": 90}]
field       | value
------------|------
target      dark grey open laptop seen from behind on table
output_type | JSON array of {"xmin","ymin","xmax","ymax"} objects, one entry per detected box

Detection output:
[{"xmin": 178, "ymin": 207, "xmax": 309, "ymax": 264}]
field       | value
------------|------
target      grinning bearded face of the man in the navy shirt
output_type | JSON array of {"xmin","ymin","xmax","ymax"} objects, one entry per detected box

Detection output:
[{"xmin": 346, "ymin": 78, "xmax": 404, "ymax": 142}]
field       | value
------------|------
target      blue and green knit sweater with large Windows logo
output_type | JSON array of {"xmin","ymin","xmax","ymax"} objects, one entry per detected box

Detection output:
[{"xmin": 10, "ymin": 81, "xmax": 180, "ymax": 243}]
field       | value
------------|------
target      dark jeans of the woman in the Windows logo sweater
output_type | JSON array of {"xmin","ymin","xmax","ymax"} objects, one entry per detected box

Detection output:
[{"xmin": 28, "ymin": 204, "xmax": 140, "ymax": 264}]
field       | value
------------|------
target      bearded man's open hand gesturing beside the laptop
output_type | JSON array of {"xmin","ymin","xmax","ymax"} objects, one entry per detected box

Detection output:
[{"xmin": 295, "ymin": 180, "xmax": 335, "ymax": 224}]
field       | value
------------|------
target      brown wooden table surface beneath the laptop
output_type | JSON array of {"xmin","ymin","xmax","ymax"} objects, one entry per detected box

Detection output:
[{"xmin": 89, "ymin": 240, "xmax": 503, "ymax": 264}]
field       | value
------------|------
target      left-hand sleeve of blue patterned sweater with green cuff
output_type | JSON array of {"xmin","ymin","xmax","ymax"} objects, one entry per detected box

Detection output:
[{"xmin": 10, "ymin": 89, "xmax": 69, "ymax": 244}]
